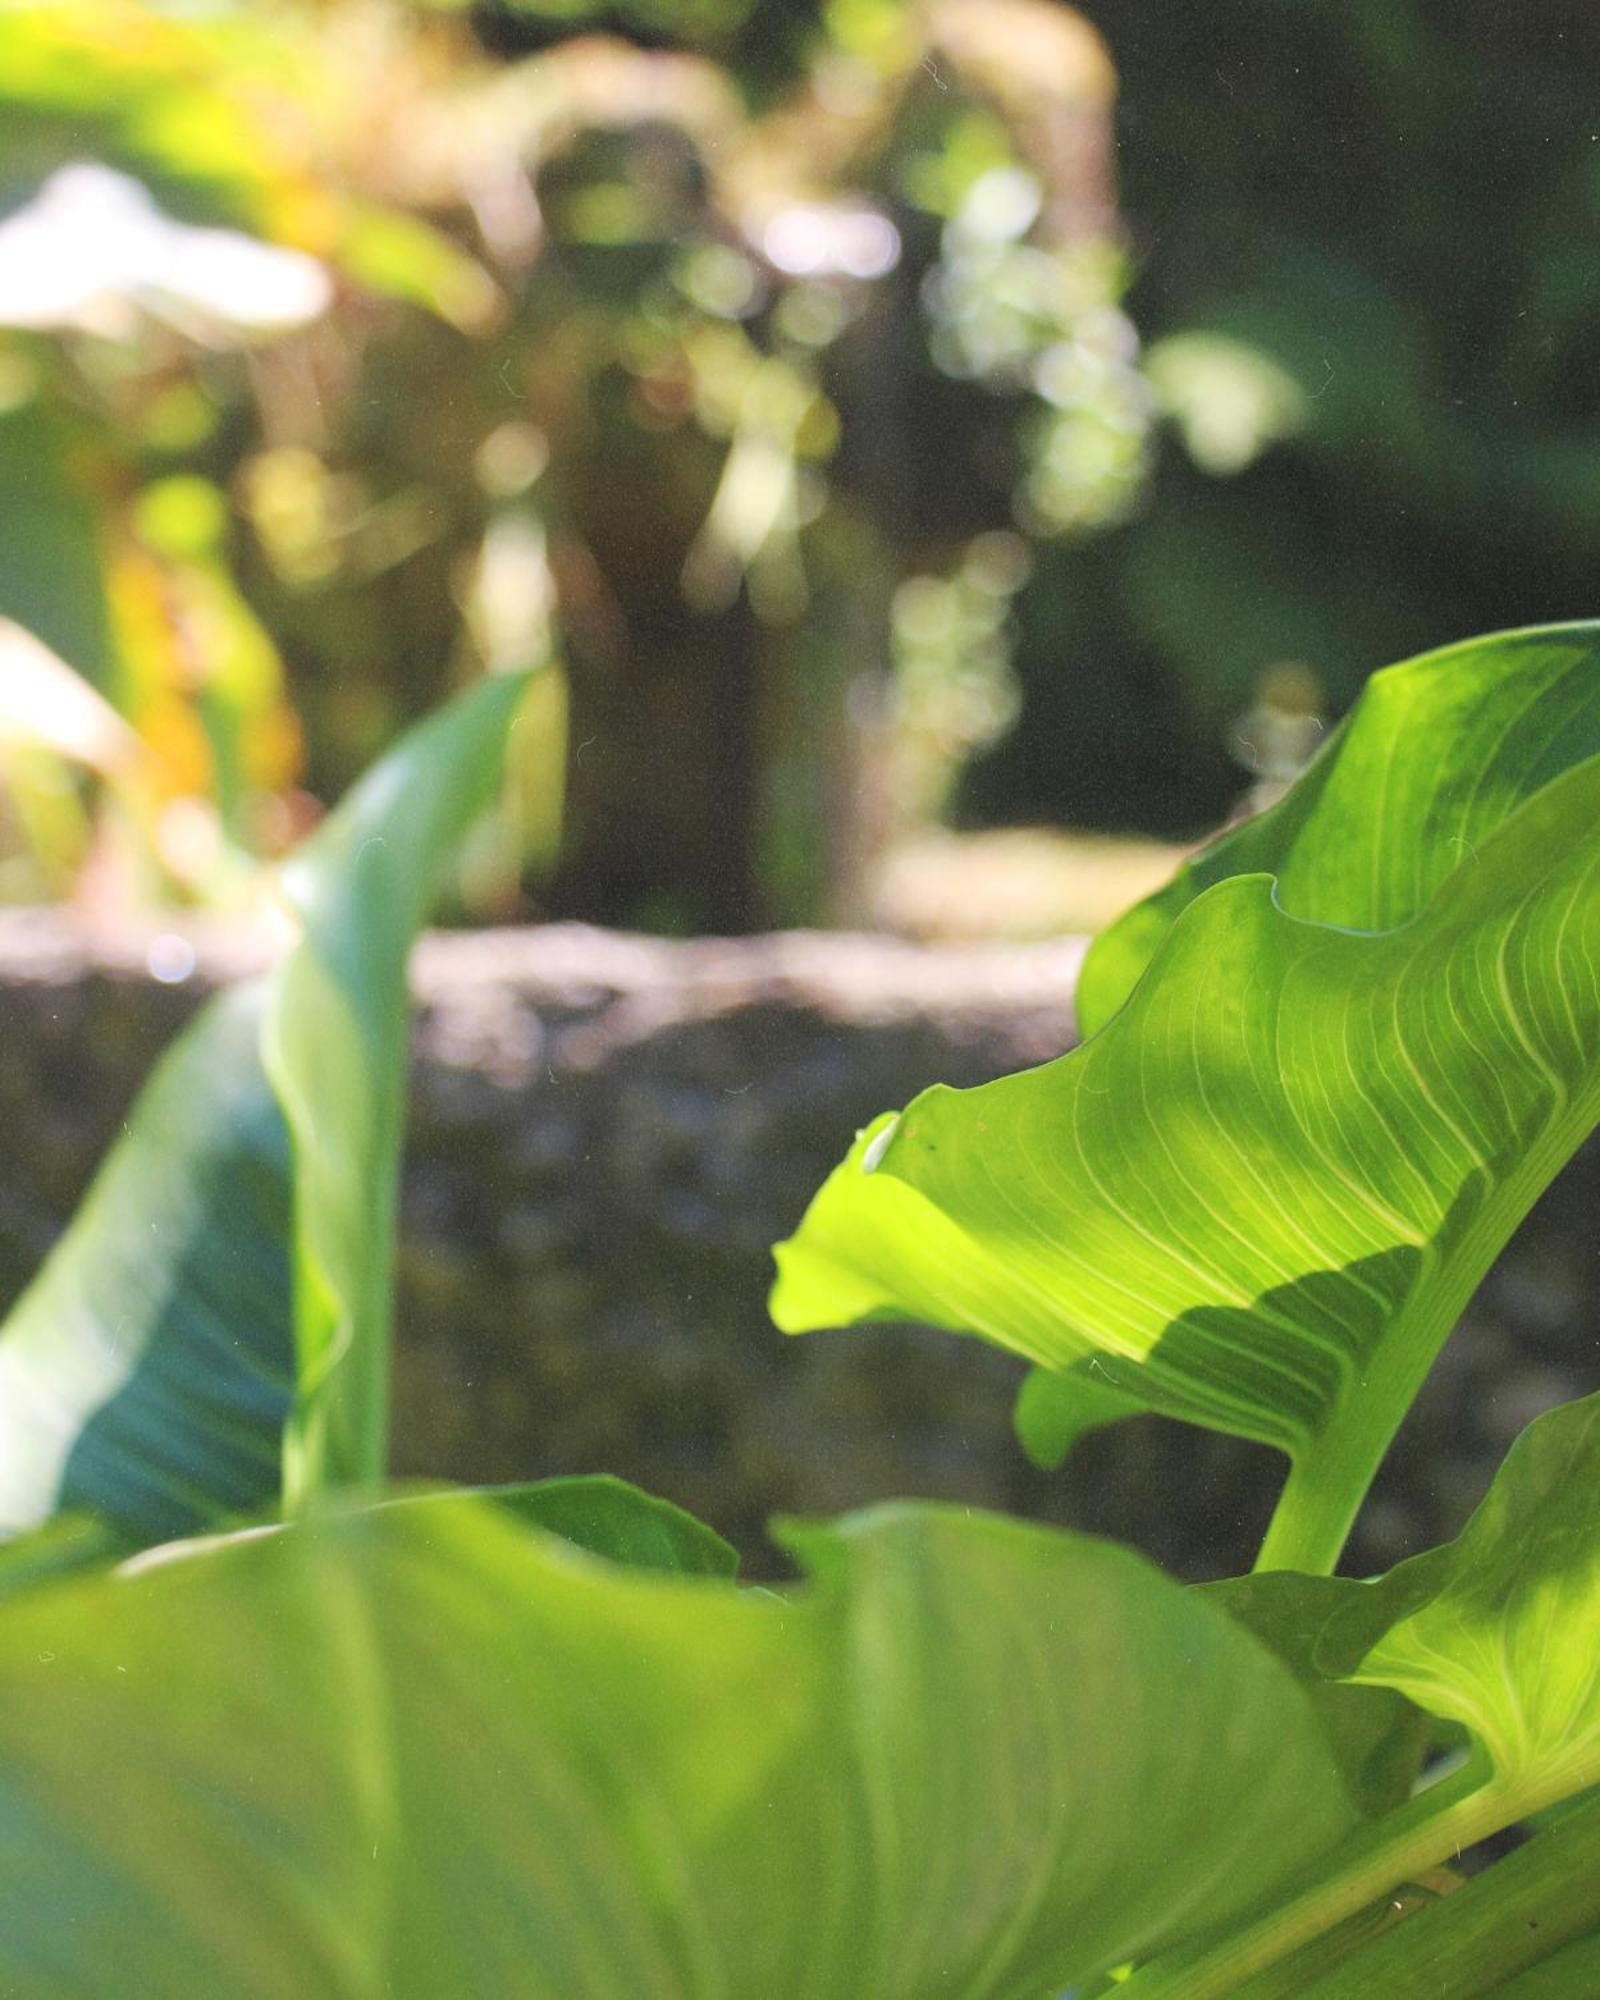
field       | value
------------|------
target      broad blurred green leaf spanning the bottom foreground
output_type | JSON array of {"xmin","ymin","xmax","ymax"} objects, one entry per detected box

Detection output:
[{"xmin": 0, "ymin": 1500, "xmax": 1350, "ymax": 2000}]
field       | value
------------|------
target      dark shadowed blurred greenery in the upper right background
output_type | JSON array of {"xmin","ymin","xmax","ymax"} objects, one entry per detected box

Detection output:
[{"xmin": 964, "ymin": 0, "xmax": 1600, "ymax": 834}]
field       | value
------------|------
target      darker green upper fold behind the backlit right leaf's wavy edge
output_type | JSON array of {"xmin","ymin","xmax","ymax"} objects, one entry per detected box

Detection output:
[{"xmin": 1074, "ymin": 624, "xmax": 1600, "ymax": 1034}]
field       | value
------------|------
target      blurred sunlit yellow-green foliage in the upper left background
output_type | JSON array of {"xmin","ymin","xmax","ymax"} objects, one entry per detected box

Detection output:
[{"xmin": 0, "ymin": 0, "xmax": 1150, "ymax": 928}]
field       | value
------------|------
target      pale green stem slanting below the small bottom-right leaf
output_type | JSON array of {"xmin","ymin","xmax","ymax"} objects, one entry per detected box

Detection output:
[{"xmin": 1118, "ymin": 1764, "xmax": 1530, "ymax": 2000}]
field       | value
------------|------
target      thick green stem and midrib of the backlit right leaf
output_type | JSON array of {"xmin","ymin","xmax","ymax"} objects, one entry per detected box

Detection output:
[{"xmin": 1256, "ymin": 1092, "xmax": 1600, "ymax": 1576}]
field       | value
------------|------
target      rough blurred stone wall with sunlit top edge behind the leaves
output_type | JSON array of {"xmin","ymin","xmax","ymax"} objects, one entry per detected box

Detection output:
[{"xmin": 0, "ymin": 914, "xmax": 1600, "ymax": 1576}]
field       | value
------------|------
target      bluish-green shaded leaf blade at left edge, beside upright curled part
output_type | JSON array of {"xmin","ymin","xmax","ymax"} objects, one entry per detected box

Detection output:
[{"xmin": 0, "ymin": 986, "xmax": 292, "ymax": 1542}]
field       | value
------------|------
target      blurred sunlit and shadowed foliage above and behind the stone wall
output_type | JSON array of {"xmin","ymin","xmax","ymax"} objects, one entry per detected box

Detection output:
[{"xmin": 0, "ymin": 0, "xmax": 1600, "ymax": 930}]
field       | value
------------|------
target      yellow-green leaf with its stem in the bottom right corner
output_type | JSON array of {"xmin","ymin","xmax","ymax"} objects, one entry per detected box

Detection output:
[{"xmin": 1130, "ymin": 1396, "xmax": 1600, "ymax": 2000}]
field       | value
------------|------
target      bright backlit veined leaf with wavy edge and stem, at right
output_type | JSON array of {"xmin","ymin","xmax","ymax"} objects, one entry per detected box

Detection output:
[{"xmin": 772, "ymin": 640, "xmax": 1600, "ymax": 1568}]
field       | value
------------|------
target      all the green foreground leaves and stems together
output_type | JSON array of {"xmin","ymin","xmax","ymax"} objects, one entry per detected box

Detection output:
[{"xmin": 0, "ymin": 626, "xmax": 1600, "ymax": 2000}]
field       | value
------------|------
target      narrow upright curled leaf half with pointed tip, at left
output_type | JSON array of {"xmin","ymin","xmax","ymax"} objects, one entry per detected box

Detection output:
[{"xmin": 262, "ymin": 674, "xmax": 528, "ymax": 1498}]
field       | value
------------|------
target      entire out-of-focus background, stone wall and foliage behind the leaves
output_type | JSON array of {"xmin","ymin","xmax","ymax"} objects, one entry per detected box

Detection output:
[{"xmin": 0, "ymin": 0, "xmax": 1600, "ymax": 1570}]
